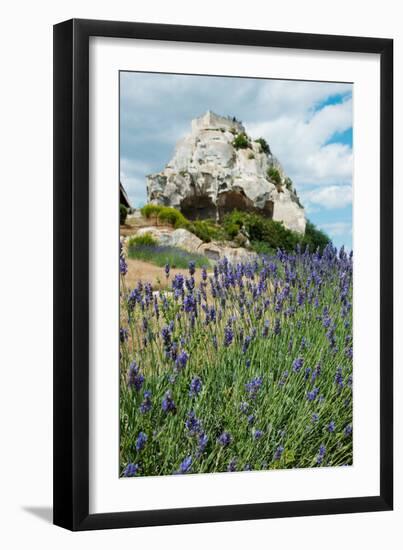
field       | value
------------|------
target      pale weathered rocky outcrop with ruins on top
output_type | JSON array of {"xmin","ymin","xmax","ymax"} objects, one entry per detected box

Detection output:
[{"xmin": 147, "ymin": 111, "xmax": 306, "ymax": 233}]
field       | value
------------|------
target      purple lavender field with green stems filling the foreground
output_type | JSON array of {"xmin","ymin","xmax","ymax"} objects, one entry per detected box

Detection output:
[{"xmin": 120, "ymin": 245, "xmax": 353, "ymax": 477}]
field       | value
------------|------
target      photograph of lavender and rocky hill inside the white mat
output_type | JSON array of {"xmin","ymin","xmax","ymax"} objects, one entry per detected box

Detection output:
[{"xmin": 119, "ymin": 71, "xmax": 353, "ymax": 477}]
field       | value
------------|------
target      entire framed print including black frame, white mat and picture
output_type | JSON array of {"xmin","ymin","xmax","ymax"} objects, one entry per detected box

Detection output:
[{"xmin": 54, "ymin": 20, "xmax": 393, "ymax": 530}]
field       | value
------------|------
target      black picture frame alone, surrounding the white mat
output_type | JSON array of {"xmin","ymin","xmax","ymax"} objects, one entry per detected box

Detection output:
[{"xmin": 54, "ymin": 19, "xmax": 393, "ymax": 531}]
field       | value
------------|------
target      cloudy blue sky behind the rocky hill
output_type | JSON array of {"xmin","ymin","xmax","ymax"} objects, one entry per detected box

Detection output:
[{"xmin": 120, "ymin": 72, "xmax": 353, "ymax": 249}]
